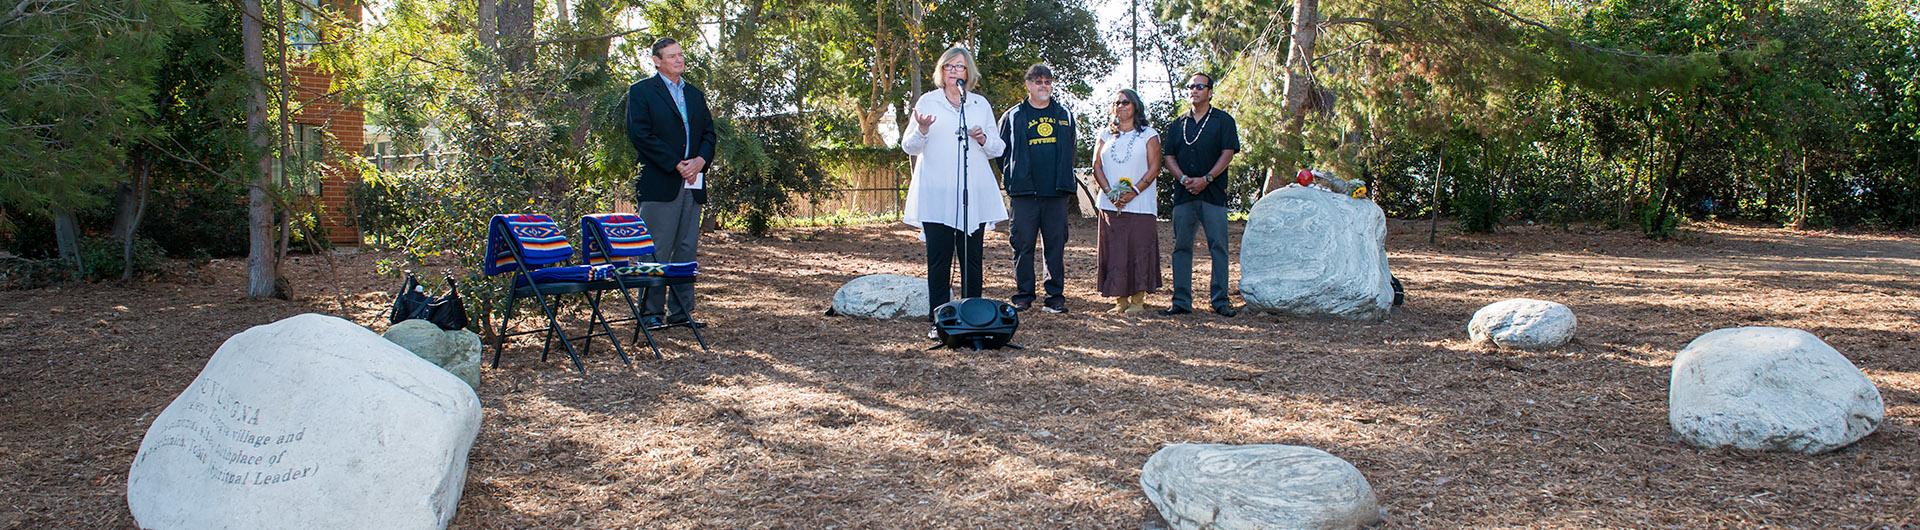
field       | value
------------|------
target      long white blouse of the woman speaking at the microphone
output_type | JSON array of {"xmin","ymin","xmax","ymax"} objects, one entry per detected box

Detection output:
[{"xmin": 900, "ymin": 88, "xmax": 1006, "ymax": 236}]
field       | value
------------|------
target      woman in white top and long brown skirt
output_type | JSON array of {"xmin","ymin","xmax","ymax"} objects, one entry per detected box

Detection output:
[{"xmin": 1092, "ymin": 90, "xmax": 1160, "ymax": 313}]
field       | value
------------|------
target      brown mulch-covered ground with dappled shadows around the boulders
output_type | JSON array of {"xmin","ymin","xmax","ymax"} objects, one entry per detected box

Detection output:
[{"xmin": 0, "ymin": 221, "xmax": 1920, "ymax": 528}]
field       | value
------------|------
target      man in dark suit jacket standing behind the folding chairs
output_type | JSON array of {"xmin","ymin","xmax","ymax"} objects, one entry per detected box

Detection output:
[{"xmin": 626, "ymin": 38, "xmax": 718, "ymax": 325}]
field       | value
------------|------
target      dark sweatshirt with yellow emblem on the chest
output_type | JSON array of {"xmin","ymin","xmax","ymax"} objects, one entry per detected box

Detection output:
[{"xmin": 998, "ymin": 100, "xmax": 1077, "ymax": 198}]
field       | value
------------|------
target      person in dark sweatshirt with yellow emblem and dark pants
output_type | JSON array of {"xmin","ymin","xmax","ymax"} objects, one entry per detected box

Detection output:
[{"xmin": 1000, "ymin": 65, "xmax": 1075, "ymax": 313}]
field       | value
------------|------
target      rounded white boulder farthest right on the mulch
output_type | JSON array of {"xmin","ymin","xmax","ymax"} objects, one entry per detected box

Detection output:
[{"xmin": 1667, "ymin": 326, "xmax": 1885, "ymax": 455}]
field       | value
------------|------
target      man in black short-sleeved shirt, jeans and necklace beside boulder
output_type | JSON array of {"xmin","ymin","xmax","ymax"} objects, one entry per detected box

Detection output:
[{"xmin": 1160, "ymin": 73, "xmax": 1240, "ymax": 317}]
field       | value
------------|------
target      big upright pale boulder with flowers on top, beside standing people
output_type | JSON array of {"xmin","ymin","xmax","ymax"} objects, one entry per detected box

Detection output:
[{"xmin": 1240, "ymin": 184, "xmax": 1394, "ymax": 321}]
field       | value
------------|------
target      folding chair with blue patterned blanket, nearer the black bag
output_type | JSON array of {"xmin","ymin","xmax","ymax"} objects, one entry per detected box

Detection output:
[{"xmin": 484, "ymin": 213, "xmax": 634, "ymax": 374}]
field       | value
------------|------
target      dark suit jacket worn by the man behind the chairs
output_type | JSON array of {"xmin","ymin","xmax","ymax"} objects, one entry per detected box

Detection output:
[{"xmin": 626, "ymin": 75, "xmax": 718, "ymax": 204}]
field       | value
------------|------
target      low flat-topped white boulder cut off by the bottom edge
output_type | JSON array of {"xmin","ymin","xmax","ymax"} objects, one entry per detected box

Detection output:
[{"xmin": 1140, "ymin": 444, "xmax": 1382, "ymax": 530}]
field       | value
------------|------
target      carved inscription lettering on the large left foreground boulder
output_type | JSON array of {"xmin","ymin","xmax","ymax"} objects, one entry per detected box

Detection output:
[{"xmin": 148, "ymin": 380, "xmax": 321, "ymax": 486}]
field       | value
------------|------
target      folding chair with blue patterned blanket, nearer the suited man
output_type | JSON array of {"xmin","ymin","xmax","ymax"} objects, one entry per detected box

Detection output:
[{"xmin": 580, "ymin": 213, "xmax": 708, "ymax": 359}]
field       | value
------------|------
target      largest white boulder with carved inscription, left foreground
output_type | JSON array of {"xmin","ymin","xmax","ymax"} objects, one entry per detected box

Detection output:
[{"xmin": 127, "ymin": 313, "xmax": 480, "ymax": 530}]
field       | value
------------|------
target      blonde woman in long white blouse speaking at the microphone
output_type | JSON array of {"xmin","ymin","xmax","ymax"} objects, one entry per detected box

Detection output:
[{"xmin": 900, "ymin": 46, "xmax": 1006, "ymax": 338}]
